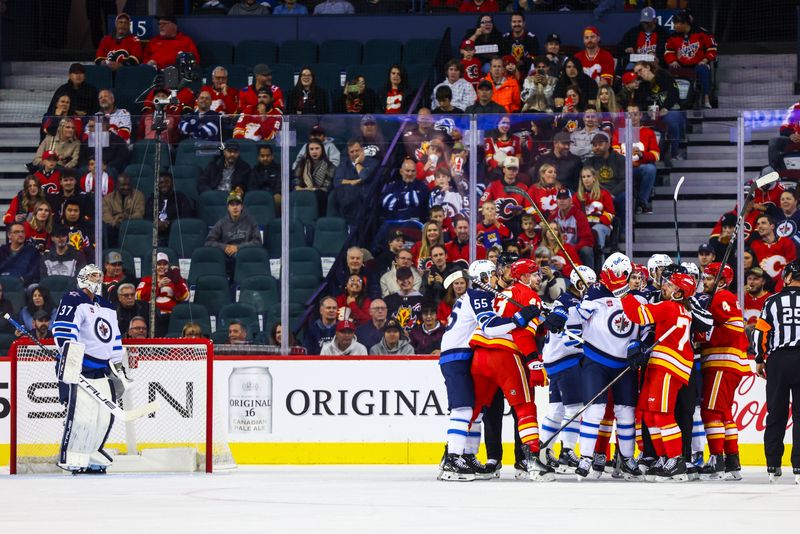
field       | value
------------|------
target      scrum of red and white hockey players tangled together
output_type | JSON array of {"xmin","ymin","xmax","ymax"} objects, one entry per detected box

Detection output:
[{"xmin": 437, "ymin": 253, "xmax": 750, "ymax": 482}]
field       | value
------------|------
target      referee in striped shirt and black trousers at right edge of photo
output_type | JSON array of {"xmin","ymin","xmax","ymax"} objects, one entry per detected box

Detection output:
[{"xmin": 753, "ymin": 261, "xmax": 800, "ymax": 484}]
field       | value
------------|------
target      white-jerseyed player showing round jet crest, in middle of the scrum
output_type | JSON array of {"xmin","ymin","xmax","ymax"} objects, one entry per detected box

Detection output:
[{"xmin": 575, "ymin": 252, "xmax": 646, "ymax": 480}]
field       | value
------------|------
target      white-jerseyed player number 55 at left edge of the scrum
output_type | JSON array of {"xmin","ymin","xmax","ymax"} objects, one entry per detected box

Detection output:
[{"xmin": 437, "ymin": 260, "xmax": 538, "ymax": 481}]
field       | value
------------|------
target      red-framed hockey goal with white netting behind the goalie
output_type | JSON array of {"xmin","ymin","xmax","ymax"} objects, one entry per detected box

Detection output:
[{"xmin": 10, "ymin": 339, "xmax": 235, "ymax": 474}]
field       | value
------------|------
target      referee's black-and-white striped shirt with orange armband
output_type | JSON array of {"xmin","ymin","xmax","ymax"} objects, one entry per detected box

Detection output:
[{"xmin": 753, "ymin": 286, "xmax": 800, "ymax": 363}]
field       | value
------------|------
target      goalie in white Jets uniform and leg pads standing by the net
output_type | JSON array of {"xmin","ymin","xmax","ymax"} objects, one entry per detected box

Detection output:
[{"xmin": 53, "ymin": 264, "xmax": 131, "ymax": 474}]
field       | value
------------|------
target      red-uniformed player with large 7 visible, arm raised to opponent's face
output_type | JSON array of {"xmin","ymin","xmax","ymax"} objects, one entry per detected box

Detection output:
[{"xmin": 621, "ymin": 272, "xmax": 697, "ymax": 482}]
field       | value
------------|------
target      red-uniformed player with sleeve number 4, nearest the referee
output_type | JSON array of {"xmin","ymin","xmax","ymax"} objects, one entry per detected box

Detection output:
[{"xmin": 700, "ymin": 262, "xmax": 751, "ymax": 480}]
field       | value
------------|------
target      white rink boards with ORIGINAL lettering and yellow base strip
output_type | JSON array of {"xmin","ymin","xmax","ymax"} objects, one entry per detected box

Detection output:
[{"xmin": 0, "ymin": 356, "xmax": 788, "ymax": 465}]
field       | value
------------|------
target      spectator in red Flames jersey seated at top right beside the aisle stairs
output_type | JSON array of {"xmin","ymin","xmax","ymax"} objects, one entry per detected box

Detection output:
[{"xmin": 664, "ymin": 9, "xmax": 717, "ymax": 109}]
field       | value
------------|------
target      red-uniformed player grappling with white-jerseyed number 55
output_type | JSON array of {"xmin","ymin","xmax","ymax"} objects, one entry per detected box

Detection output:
[{"xmin": 470, "ymin": 259, "xmax": 555, "ymax": 482}]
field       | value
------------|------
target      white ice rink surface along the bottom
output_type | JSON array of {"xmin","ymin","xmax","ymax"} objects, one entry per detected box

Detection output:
[{"xmin": 0, "ymin": 465, "xmax": 800, "ymax": 534}]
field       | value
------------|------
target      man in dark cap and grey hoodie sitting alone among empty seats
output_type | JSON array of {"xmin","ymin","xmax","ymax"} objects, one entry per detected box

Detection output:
[{"xmin": 205, "ymin": 192, "xmax": 262, "ymax": 276}]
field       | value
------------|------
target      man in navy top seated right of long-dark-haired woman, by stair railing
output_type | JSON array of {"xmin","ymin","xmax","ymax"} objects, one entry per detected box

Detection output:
[{"xmin": 333, "ymin": 139, "xmax": 378, "ymax": 226}]
